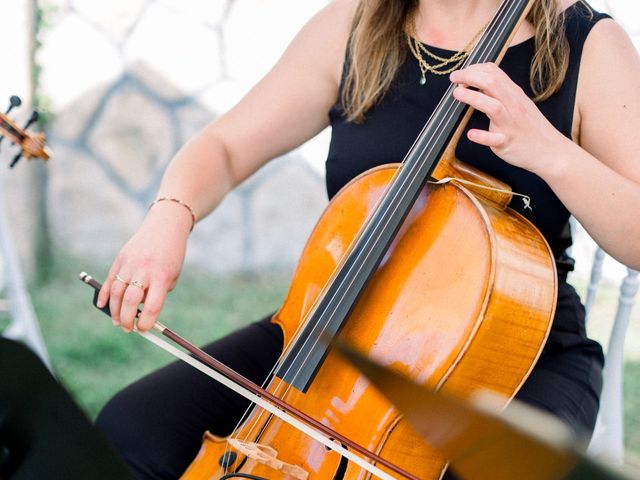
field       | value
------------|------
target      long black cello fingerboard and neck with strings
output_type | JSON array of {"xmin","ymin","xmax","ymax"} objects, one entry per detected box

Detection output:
[{"xmin": 276, "ymin": 0, "xmax": 533, "ymax": 392}]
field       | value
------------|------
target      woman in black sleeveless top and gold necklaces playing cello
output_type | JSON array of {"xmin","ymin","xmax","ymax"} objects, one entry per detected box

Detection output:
[{"xmin": 92, "ymin": 0, "xmax": 640, "ymax": 479}]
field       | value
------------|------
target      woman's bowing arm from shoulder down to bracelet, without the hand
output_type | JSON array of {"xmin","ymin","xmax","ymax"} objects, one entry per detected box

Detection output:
[{"xmin": 159, "ymin": 1, "xmax": 351, "ymax": 218}]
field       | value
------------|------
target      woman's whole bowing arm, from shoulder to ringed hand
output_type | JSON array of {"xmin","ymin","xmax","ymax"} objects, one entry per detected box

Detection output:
[{"xmin": 99, "ymin": 0, "xmax": 352, "ymax": 331}]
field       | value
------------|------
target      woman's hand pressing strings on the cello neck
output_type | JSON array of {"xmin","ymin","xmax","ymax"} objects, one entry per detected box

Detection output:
[{"xmin": 450, "ymin": 63, "xmax": 567, "ymax": 176}]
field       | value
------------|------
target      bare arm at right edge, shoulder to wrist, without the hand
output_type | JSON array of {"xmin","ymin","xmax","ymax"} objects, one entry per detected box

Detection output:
[{"xmin": 544, "ymin": 20, "xmax": 640, "ymax": 269}]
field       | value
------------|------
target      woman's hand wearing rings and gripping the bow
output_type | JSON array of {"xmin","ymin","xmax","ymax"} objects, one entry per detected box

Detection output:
[{"xmin": 97, "ymin": 201, "xmax": 192, "ymax": 332}]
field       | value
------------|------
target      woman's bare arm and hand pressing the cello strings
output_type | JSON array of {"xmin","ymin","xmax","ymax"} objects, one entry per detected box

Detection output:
[{"xmin": 451, "ymin": 20, "xmax": 640, "ymax": 269}]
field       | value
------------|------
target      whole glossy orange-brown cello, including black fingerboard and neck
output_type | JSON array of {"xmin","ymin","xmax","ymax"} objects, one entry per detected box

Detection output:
[{"xmin": 87, "ymin": 0, "xmax": 556, "ymax": 479}]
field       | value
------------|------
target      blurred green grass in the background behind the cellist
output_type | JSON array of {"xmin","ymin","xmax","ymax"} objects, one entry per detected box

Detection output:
[{"xmin": 13, "ymin": 259, "xmax": 640, "ymax": 464}]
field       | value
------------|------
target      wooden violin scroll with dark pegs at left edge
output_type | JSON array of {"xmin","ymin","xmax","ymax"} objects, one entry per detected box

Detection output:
[{"xmin": 0, "ymin": 95, "xmax": 51, "ymax": 168}]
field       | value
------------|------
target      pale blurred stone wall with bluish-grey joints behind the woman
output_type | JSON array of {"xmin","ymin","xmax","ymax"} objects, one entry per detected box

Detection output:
[{"xmin": 39, "ymin": 0, "xmax": 326, "ymax": 272}]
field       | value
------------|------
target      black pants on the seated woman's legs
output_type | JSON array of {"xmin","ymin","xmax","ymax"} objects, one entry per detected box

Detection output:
[{"xmin": 97, "ymin": 284, "xmax": 603, "ymax": 480}]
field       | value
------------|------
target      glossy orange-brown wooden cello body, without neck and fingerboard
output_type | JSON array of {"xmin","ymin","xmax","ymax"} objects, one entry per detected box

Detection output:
[{"xmin": 181, "ymin": 162, "xmax": 557, "ymax": 480}]
